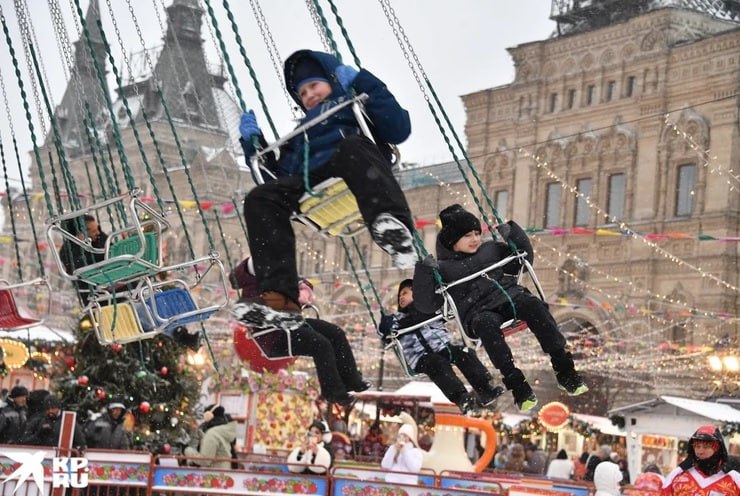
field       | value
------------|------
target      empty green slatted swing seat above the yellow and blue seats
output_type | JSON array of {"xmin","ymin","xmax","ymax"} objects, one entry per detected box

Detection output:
[{"xmin": 77, "ymin": 233, "xmax": 159, "ymax": 286}]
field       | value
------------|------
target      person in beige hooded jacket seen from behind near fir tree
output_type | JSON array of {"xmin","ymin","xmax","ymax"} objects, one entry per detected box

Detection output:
[{"xmin": 184, "ymin": 404, "xmax": 236, "ymax": 469}]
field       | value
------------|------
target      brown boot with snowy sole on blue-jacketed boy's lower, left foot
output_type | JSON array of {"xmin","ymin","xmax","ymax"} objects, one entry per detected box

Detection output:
[{"xmin": 231, "ymin": 291, "xmax": 305, "ymax": 331}]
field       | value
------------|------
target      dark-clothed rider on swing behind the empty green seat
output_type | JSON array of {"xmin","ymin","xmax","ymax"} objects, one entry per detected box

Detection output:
[{"xmin": 59, "ymin": 214, "xmax": 108, "ymax": 307}]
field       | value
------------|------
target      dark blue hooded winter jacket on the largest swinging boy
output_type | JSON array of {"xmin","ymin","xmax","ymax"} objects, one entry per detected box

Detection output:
[{"xmin": 240, "ymin": 50, "xmax": 411, "ymax": 176}]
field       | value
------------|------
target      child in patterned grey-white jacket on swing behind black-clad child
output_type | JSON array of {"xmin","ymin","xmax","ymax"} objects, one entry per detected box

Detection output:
[{"xmin": 379, "ymin": 279, "xmax": 504, "ymax": 415}]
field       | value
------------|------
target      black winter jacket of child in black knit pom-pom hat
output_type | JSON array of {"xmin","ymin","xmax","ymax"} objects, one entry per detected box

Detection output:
[{"xmin": 413, "ymin": 221, "xmax": 534, "ymax": 327}]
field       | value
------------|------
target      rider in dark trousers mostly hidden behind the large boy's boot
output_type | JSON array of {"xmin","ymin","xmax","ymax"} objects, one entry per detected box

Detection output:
[{"xmin": 229, "ymin": 258, "xmax": 370, "ymax": 407}]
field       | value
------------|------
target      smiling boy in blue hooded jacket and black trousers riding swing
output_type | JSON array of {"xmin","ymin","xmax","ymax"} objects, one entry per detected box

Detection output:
[{"xmin": 232, "ymin": 50, "xmax": 417, "ymax": 328}]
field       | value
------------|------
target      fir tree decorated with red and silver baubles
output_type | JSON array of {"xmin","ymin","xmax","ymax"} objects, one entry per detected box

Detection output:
[{"xmin": 55, "ymin": 319, "xmax": 199, "ymax": 453}]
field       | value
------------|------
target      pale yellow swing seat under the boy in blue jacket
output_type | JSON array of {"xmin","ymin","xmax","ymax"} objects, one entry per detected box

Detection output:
[{"xmin": 295, "ymin": 178, "xmax": 365, "ymax": 237}]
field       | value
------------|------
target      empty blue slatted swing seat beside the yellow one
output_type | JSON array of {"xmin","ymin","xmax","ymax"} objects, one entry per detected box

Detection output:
[{"xmin": 136, "ymin": 287, "xmax": 218, "ymax": 333}]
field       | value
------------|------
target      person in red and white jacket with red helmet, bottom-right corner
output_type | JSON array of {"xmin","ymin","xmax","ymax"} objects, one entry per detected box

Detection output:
[{"xmin": 661, "ymin": 425, "xmax": 740, "ymax": 496}]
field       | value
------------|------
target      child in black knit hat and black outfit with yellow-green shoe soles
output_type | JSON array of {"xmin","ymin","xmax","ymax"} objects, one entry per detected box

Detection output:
[{"xmin": 414, "ymin": 205, "xmax": 588, "ymax": 411}]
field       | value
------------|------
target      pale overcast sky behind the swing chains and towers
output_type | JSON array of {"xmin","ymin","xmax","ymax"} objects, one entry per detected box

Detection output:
[{"xmin": 0, "ymin": 0, "xmax": 555, "ymax": 190}]
